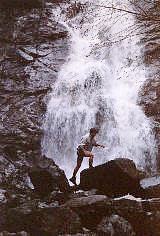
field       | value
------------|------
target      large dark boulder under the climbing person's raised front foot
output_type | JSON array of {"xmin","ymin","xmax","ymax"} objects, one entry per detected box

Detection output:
[{"xmin": 80, "ymin": 158, "xmax": 144, "ymax": 197}]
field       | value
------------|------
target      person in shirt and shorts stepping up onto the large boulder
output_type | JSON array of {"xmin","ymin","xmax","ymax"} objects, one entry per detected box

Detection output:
[{"xmin": 69, "ymin": 128, "xmax": 105, "ymax": 184}]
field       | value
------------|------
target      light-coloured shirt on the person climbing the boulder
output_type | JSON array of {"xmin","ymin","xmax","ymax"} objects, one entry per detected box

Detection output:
[{"xmin": 78, "ymin": 133, "xmax": 98, "ymax": 152}]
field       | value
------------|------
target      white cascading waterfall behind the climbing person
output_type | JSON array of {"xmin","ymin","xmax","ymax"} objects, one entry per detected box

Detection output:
[{"xmin": 42, "ymin": 0, "xmax": 156, "ymax": 179}]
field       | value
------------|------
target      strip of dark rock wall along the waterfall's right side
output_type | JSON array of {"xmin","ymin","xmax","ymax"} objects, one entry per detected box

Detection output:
[{"xmin": 139, "ymin": 0, "xmax": 160, "ymax": 163}]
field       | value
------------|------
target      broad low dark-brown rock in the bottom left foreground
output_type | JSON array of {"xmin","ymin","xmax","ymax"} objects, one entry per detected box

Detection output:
[{"xmin": 7, "ymin": 202, "xmax": 82, "ymax": 235}]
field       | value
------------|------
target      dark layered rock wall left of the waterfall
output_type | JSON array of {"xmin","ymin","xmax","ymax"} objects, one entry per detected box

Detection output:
[{"xmin": 0, "ymin": 1, "xmax": 68, "ymax": 168}]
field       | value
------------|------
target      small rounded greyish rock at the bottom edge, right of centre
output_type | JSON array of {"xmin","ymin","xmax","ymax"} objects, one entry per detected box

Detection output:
[{"xmin": 97, "ymin": 215, "xmax": 136, "ymax": 236}]
